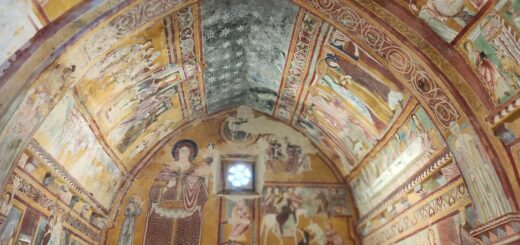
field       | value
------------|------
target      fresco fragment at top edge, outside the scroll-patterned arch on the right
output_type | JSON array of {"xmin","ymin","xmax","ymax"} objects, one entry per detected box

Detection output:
[{"xmin": 406, "ymin": 0, "xmax": 488, "ymax": 42}]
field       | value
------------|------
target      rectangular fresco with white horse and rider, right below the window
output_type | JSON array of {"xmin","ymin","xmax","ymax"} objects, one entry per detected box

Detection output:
[{"xmin": 260, "ymin": 186, "xmax": 352, "ymax": 244}]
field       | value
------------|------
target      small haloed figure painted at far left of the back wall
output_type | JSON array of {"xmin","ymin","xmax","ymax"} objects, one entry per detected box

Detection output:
[{"xmin": 117, "ymin": 196, "xmax": 142, "ymax": 245}]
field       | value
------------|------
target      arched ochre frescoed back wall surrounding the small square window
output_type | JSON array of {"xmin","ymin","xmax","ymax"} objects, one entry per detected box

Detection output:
[{"xmin": 101, "ymin": 115, "xmax": 354, "ymax": 244}]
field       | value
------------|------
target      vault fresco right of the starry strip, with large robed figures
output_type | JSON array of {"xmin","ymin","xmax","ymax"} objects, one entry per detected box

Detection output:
[{"xmin": 298, "ymin": 27, "xmax": 407, "ymax": 165}]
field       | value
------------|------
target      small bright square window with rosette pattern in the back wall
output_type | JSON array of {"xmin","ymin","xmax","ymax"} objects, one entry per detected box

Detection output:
[{"xmin": 222, "ymin": 161, "xmax": 255, "ymax": 194}]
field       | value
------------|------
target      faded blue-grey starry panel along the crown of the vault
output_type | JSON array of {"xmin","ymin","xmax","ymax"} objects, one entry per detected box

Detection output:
[{"xmin": 201, "ymin": 0, "xmax": 298, "ymax": 112}]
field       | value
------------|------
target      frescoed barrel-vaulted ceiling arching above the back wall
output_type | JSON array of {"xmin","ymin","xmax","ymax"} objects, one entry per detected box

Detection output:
[{"xmin": 0, "ymin": 0, "xmax": 520, "ymax": 240}]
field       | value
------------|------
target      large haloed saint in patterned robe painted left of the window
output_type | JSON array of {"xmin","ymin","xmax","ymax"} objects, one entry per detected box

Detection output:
[{"xmin": 144, "ymin": 139, "xmax": 209, "ymax": 245}]
